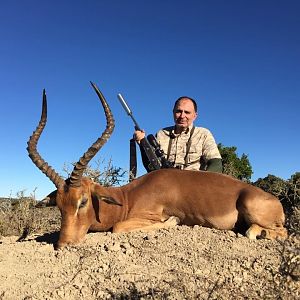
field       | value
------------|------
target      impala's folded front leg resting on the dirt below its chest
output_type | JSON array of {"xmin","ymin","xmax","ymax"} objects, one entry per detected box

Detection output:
[{"xmin": 113, "ymin": 216, "xmax": 180, "ymax": 233}]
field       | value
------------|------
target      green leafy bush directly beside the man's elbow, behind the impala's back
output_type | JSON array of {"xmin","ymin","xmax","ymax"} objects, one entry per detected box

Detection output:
[{"xmin": 218, "ymin": 143, "xmax": 253, "ymax": 182}]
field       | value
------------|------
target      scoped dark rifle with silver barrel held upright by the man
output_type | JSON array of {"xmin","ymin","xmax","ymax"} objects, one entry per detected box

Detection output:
[{"xmin": 118, "ymin": 94, "xmax": 172, "ymax": 177}]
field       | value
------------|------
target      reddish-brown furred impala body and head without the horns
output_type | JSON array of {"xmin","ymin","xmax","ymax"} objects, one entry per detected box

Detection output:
[{"xmin": 51, "ymin": 169, "xmax": 287, "ymax": 247}]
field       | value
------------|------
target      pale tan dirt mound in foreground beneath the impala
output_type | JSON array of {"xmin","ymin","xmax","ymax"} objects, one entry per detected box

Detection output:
[{"xmin": 0, "ymin": 226, "xmax": 300, "ymax": 299}]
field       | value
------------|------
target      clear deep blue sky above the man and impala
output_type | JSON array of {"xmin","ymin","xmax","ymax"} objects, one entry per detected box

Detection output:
[{"xmin": 0, "ymin": 0, "xmax": 300, "ymax": 199}]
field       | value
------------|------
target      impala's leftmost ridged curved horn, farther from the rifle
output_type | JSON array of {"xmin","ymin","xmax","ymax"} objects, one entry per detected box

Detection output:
[{"xmin": 27, "ymin": 89, "xmax": 64, "ymax": 188}]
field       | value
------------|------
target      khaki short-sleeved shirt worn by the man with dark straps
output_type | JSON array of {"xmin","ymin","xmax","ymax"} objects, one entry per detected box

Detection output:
[{"xmin": 156, "ymin": 125, "xmax": 221, "ymax": 170}]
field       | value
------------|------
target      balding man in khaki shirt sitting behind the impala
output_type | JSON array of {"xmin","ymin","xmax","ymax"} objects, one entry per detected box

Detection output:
[{"xmin": 135, "ymin": 96, "xmax": 222, "ymax": 173}]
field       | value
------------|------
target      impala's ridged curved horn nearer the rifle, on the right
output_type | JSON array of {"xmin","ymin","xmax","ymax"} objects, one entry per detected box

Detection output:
[{"xmin": 70, "ymin": 82, "xmax": 115, "ymax": 187}]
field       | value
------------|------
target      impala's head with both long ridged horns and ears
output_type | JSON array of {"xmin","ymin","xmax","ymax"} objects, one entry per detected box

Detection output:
[{"xmin": 27, "ymin": 83, "xmax": 118, "ymax": 247}]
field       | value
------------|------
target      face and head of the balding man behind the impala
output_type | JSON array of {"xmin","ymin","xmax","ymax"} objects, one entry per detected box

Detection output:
[{"xmin": 173, "ymin": 98, "xmax": 197, "ymax": 129}]
